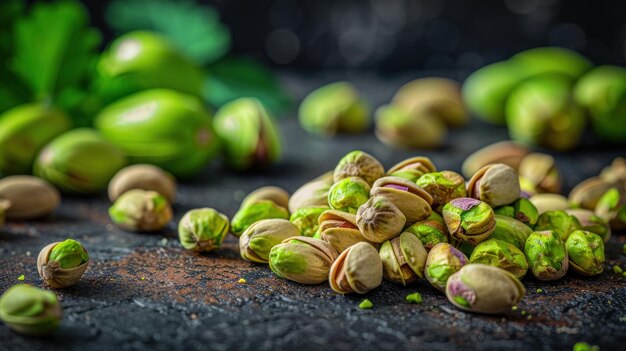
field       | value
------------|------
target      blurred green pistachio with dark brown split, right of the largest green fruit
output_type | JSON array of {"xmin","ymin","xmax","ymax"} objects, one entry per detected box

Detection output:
[{"xmin": 213, "ymin": 98, "xmax": 282, "ymax": 170}]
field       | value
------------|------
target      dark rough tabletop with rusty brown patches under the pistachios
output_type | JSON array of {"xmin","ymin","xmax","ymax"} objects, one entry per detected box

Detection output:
[{"xmin": 0, "ymin": 75, "xmax": 626, "ymax": 351}]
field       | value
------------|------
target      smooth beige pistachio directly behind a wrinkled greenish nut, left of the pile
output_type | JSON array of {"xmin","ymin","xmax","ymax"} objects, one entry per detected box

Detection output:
[{"xmin": 108, "ymin": 164, "xmax": 176, "ymax": 203}]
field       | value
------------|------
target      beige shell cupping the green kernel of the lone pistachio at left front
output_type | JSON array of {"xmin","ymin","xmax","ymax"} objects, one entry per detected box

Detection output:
[{"xmin": 37, "ymin": 242, "xmax": 89, "ymax": 289}]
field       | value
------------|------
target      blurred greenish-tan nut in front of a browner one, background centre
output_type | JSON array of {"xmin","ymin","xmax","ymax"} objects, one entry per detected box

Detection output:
[{"xmin": 375, "ymin": 105, "xmax": 447, "ymax": 149}]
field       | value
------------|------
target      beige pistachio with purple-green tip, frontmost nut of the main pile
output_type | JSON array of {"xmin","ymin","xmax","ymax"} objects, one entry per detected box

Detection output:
[{"xmin": 446, "ymin": 263, "xmax": 526, "ymax": 314}]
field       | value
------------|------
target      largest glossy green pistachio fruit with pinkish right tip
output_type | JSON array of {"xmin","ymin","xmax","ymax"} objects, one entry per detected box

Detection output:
[{"xmin": 94, "ymin": 89, "xmax": 219, "ymax": 177}]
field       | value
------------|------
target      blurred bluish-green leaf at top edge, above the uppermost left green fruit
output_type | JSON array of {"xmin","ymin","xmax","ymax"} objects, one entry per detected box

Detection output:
[{"xmin": 106, "ymin": 0, "xmax": 230, "ymax": 65}]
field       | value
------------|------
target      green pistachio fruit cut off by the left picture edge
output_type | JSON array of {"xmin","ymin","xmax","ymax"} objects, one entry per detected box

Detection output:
[{"xmin": 0, "ymin": 104, "xmax": 71, "ymax": 176}]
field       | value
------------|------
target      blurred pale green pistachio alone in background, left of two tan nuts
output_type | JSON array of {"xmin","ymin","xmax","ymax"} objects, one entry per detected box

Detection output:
[{"xmin": 298, "ymin": 82, "xmax": 370, "ymax": 136}]
